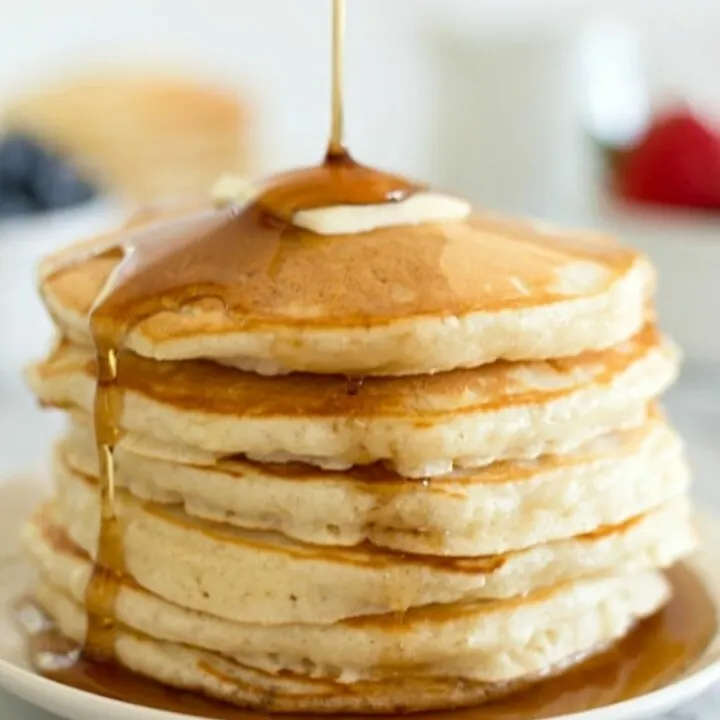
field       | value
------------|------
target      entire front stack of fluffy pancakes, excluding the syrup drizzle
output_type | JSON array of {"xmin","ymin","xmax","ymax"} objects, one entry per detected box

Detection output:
[{"xmin": 26, "ymin": 204, "xmax": 695, "ymax": 712}]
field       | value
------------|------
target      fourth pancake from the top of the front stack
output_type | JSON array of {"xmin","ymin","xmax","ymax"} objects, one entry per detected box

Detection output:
[{"xmin": 50, "ymin": 462, "xmax": 695, "ymax": 624}]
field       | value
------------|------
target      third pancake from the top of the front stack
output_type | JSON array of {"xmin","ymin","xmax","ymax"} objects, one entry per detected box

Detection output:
[{"xmin": 63, "ymin": 412, "xmax": 689, "ymax": 556}]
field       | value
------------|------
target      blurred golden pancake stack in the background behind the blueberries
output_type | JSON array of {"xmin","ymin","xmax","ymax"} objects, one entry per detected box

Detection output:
[{"xmin": 0, "ymin": 73, "xmax": 250, "ymax": 203}]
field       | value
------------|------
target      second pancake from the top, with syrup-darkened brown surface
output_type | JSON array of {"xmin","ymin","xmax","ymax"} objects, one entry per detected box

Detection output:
[{"xmin": 28, "ymin": 326, "xmax": 678, "ymax": 477}]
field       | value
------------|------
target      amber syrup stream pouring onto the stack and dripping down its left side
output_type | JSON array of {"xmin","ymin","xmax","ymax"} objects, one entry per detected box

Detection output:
[{"xmin": 84, "ymin": 0, "xmax": 420, "ymax": 661}]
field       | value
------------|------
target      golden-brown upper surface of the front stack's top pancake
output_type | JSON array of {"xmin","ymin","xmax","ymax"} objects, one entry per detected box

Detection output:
[{"xmin": 41, "ymin": 202, "xmax": 638, "ymax": 340}]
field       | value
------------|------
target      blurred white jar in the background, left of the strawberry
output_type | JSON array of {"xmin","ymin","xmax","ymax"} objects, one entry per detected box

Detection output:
[{"xmin": 427, "ymin": 18, "xmax": 592, "ymax": 218}]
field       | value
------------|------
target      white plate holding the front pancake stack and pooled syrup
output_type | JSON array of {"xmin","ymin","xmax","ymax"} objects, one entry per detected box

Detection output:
[{"xmin": 0, "ymin": 481, "xmax": 720, "ymax": 720}]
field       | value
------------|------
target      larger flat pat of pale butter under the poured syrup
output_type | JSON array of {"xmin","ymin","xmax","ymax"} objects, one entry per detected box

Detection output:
[{"xmin": 292, "ymin": 192, "xmax": 471, "ymax": 235}]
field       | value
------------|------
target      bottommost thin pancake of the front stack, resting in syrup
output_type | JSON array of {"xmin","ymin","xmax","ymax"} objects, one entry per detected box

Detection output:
[{"xmin": 31, "ymin": 578, "xmax": 672, "ymax": 714}]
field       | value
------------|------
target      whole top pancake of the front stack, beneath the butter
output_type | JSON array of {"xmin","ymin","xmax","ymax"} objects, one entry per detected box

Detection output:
[{"xmin": 41, "ymin": 200, "xmax": 653, "ymax": 375}]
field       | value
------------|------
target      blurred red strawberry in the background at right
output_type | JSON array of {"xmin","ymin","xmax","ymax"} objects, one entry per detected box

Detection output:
[{"xmin": 620, "ymin": 111, "xmax": 720, "ymax": 209}]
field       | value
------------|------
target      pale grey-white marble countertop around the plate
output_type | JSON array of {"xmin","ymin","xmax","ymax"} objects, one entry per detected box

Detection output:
[{"xmin": 0, "ymin": 363, "xmax": 720, "ymax": 720}]
